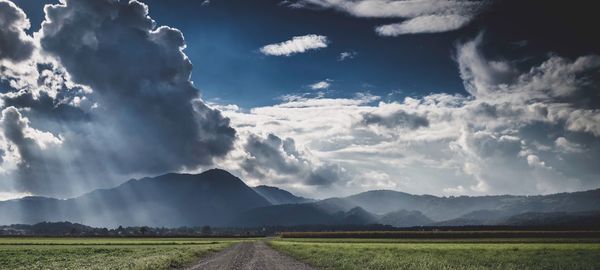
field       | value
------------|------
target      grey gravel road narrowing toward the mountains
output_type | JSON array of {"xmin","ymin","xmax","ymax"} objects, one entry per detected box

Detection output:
[{"xmin": 186, "ymin": 241, "xmax": 315, "ymax": 270}]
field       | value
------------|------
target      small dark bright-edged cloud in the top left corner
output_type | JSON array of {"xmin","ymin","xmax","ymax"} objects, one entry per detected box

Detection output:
[{"xmin": 0, "ymin": 0, "xmax": 34, "ymax": 61}]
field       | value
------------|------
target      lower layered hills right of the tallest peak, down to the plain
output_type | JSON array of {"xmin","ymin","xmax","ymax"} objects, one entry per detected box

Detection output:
[{"xmin": 238, "ymin": 190, "xmax": 600, "ymax": 227}]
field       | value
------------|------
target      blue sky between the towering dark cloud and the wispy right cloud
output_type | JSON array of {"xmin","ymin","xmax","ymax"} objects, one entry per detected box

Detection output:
[{"xmin": 16, "ymin": 0, "xmax": 477, "ymax": 108}]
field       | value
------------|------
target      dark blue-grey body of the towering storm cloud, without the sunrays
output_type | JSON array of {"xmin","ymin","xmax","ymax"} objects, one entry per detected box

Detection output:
[{"xmin": 41, "ymin": 0, "xmax": 235, "ymax": 172}]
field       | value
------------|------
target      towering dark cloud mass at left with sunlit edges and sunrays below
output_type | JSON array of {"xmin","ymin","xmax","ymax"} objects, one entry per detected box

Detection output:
[{"xmin": 0, "ymin": 0, "xmax": 236, "ymax": 196}]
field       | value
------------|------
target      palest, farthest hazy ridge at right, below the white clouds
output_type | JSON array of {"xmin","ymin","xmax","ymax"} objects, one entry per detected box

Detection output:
[{"xmin": 318, "ymin": 189, "xmax": 600, "ymax": 221}]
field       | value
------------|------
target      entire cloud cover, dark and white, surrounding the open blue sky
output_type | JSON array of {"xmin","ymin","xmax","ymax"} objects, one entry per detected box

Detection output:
[{"xmin": 0, "ymin": 0, "xmax": 600, "ymax": 198}]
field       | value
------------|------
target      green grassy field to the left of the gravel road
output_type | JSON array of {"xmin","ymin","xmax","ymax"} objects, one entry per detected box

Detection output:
[{"xmin": 0, "ymin": 238, "xmax": 241, "ymax": 270}]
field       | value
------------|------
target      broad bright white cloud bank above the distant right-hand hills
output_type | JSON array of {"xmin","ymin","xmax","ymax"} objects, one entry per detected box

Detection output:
[{"xmin": 216, "ymin": 36, "xmax": 600, "ymax": 195}]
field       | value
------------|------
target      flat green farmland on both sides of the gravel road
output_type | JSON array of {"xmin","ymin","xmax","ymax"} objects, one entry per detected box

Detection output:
[{"xmin": 0, "ymin": 231, "xmax": 600, "ymax": 270}]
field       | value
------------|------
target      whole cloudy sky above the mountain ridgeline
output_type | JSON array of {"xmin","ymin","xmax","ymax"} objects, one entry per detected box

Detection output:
[{"xmin": 0, "ymin": 0, "xmax": 600, "ymax": 200}]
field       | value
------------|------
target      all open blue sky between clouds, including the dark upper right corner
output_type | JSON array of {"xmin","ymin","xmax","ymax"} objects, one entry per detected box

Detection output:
[{"xmin": 16, "ymin": 0, "xmax": 600, "ymax": 108}]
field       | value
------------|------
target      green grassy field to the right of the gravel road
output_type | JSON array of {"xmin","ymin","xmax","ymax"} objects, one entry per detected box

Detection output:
[{"xmin": 270, "ymin": 239, "xmax": 600, "ymax": 270}]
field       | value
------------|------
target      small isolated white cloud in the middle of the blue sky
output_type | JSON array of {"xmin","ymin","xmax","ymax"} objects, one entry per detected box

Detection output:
[{"xmin": 260, "ymin": 34, "xmax": 329, "ymax": 56}]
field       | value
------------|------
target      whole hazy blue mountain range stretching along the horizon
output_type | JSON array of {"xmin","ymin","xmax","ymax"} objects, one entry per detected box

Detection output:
[{"xmin": 0, "ymin": 169, "xmax": 600, "ymax": 227}]
